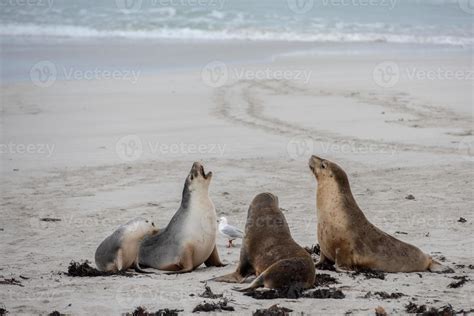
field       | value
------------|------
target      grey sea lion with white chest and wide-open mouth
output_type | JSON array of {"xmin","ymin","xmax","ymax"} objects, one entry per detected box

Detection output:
[{"xmin": 140, "ymin": 162, "xmax": 223, "ymax": 273}]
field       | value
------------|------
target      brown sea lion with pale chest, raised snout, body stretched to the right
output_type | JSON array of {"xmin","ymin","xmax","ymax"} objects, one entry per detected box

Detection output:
[{"xmin": 309, "ymin": 156, "xmax": 450, "ymax": 272}]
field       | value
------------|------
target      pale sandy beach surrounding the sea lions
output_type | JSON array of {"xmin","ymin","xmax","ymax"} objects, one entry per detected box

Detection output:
[{"xmin": 0, "ymin": 36, "xmax": 474, "ymax": 315}]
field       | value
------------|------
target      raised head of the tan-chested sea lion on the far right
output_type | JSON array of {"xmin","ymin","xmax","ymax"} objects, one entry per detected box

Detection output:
[{"xmin": 309, "ymin": 155, "xmax": 349, "ymax": 187}]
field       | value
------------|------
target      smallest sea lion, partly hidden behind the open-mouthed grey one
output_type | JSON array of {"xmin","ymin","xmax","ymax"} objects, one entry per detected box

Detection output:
[{"xmin": 95, "ymin": 218, "xmax": 158, "ymax": 273}]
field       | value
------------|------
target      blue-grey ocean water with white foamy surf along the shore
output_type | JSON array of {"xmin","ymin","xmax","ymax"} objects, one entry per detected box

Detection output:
[{"xmin": 0, "ymin": 0, "xmax": 474, "ymax": 48}]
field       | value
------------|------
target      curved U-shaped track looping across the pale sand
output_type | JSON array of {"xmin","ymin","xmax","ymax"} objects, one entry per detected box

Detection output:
[{"xmin": 212, "ymin": 80, "xmax": 472, "ymax": 155}]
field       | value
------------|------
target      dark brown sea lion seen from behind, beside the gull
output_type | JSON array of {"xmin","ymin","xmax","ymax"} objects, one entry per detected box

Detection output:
[{"xmin": 213, "ymin": 193, "xmax": 315, "ymax": 291}]
